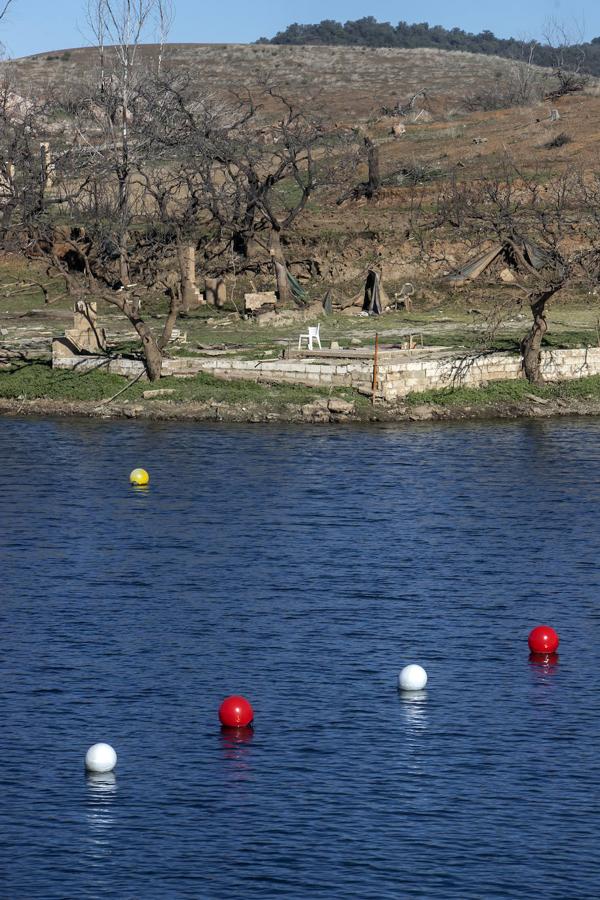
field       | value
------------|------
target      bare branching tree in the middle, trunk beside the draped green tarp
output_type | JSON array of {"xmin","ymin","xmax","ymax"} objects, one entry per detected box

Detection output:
[{"xmin": 173, "ymin": 88, "xmax": 340, "ymax": 304}]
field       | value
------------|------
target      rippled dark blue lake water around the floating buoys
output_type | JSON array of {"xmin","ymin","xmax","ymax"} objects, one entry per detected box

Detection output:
[{"xmin": 0, "ymin": 419, "xmax": 600, "ymax": 900}]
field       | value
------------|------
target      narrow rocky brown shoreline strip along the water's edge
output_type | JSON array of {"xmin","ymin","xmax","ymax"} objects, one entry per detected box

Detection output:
[{"xmin": 0, "ymin": 394, "xmax": 600, "ymax": 424}]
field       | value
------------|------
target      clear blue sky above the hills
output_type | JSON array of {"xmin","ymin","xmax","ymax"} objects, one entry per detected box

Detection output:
[{"xmin": 0, "ymin": 0, "xmax": 600, "ymax": 56}]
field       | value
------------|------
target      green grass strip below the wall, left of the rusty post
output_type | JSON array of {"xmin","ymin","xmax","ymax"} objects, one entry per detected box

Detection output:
[{"xmin": 0, "ymin": 363, "xmax": 368, "ymax": 407}]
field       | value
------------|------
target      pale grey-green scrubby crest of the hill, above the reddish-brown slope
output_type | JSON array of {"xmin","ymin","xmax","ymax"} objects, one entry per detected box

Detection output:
[{"xmin": 3, "ymin": 44, "xmax": 564, "ymax": 120}]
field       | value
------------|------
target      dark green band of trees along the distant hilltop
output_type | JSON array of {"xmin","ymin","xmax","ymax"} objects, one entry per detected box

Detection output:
[{"xmin": 259, "ymin": 16, "xmax": 600, "ymax": 75}]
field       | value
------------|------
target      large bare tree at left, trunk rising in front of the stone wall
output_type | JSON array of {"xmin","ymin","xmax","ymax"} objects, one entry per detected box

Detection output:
[{"xmin": 0, "ymin": 64, "xmax": 205, "ymax": 379}]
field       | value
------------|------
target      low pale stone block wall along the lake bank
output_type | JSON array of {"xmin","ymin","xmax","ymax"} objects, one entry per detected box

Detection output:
[{"xmin": 53, "ymin": 347, "xmax": 600, "ymax": 401}]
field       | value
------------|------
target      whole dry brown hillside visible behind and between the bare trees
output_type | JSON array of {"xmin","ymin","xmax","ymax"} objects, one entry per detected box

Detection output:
[{"xmin": 3, "ymin": 44, "xmax": 600, "ymax": 392}]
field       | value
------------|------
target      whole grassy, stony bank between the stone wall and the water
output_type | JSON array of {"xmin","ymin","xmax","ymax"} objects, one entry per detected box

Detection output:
[{"xmin": 0, "ymin": 363, "xmax": 600, "ymax": 421}]
